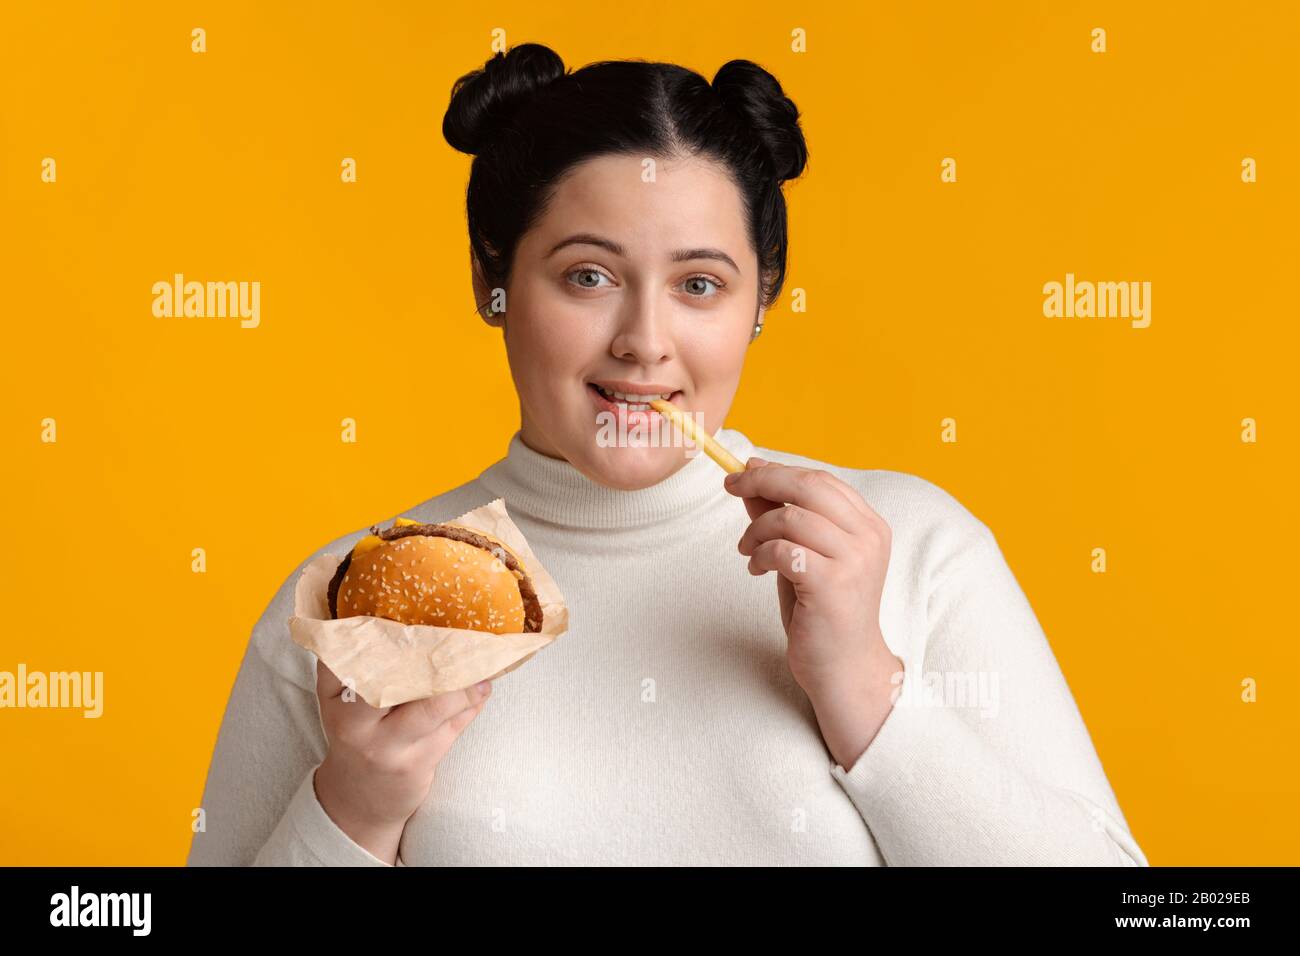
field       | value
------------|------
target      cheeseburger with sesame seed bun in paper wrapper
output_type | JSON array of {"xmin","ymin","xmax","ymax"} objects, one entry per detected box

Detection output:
[{"xmin": 329, "ymin": 518, "xmax": 542, "ymax": 633}]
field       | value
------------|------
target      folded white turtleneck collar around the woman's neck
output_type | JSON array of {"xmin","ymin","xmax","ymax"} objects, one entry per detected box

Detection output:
[{"xmin": 478, "ymin": 428, "xmax": 754, "ymax": 529}]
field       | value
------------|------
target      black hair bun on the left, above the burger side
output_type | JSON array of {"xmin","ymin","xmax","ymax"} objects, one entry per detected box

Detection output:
[{"xmin": 442, "ymin": 43, "xmax": 564, "ymax": 155}]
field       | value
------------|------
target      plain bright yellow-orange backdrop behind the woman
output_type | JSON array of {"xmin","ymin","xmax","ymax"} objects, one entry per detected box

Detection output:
[{"xmin": 0, "ymin": 0, "xmax": 1300, "ymax": 865}]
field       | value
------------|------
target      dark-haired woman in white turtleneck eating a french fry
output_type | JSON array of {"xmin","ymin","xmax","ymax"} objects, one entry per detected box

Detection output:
[{"xmin": 190, "ymin": 44, "xmax": 1147, "ymax": 866}]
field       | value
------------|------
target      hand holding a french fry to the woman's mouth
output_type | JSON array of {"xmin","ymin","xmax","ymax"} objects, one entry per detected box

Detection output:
[{"xmin": 724, "ymin": 457, "xmax": 904, "ymax": 769}]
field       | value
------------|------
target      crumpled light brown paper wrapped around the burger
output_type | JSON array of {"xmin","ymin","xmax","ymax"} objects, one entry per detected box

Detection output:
[{"xmin": 289, "ymin": 498, "xmax": 568, "ymax": 708}]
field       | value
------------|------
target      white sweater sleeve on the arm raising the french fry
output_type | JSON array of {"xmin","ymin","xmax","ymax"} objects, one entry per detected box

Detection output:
[{"xmin": 831, "ymin": 515, "xmax": 1148, "ymax": 866}]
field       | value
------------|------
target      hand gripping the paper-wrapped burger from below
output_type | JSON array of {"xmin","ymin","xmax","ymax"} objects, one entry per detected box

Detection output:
[{"xmin": 315, "ymin": 658, "xmax": 491, "ymax": 864}]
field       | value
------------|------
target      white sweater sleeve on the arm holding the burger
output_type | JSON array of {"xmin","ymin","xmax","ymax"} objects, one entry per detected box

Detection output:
[{"xmin": 187, "ymin": 575, "xmax": 387, "ymax": 866}]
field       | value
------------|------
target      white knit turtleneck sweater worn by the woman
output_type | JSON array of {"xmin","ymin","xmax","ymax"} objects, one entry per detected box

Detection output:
[{"xmin": 189, "ymin": 429, "xmax": 1147, "ymax": 866}]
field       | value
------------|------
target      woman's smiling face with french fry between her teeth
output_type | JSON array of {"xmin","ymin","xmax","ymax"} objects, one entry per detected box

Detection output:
[{"xmin": 475, "ymin": 156, "xmax": 761, "ymax": 489}]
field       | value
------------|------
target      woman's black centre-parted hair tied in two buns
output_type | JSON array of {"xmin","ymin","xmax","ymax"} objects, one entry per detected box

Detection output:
[{"xmin": 442, "ymin": 43, "xmax": 807, "ymax": 307}]
